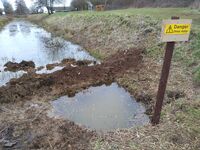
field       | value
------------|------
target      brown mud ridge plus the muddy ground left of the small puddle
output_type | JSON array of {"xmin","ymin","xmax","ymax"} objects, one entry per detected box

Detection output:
[{"xmin": 0, "ymin": 49, "xmax": 143, "ymax": 150}]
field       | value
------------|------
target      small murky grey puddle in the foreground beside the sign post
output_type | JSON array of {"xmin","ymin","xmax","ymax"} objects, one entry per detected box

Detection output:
[{"xmin": 49, "ymin": 83, "xmax": 149, "ymax": 131}]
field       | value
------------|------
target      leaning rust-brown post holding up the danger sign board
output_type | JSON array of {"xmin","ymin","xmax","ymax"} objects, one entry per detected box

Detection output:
[{"xmin": 152, "ymin": 17, "xmax": 179, "ymax": 125}]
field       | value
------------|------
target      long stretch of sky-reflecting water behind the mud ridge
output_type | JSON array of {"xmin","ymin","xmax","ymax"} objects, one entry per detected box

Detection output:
[{"xmin": 0, "ymin": 20, "xmax": 95, "ymax": 86}]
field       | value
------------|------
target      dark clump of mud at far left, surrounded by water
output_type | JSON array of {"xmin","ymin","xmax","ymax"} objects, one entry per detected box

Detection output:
[{"xmin": 4, "ymin": 60, "xmax": 35, "ymax": 72}]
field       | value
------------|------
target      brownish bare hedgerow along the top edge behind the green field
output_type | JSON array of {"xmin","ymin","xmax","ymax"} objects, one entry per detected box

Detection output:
[{"xmin": 71, "ymin": 0, "xmax": 200, "ymax": 10}]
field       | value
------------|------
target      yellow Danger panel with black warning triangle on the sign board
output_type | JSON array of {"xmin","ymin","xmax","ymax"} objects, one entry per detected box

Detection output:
[{"xmin": 164, "ymin": 24, "xmax": 191, "ymax": 34}]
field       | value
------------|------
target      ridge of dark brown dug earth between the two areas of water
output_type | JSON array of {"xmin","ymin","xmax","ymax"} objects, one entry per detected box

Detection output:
[{"xmin": 0, "ymin": 49, "xmax": 142, "ymax": 103}]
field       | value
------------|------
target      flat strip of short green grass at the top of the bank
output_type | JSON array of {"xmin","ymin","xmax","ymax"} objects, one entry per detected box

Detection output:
[{"xmin": 54, "ymin": 8, "xmax": 200, "ymax": 26}]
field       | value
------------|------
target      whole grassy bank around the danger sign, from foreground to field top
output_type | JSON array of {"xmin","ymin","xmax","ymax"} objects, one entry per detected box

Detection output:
[{"xmin": 28, "ymin": 8, "xmax": 200, "ymax": 150}]
